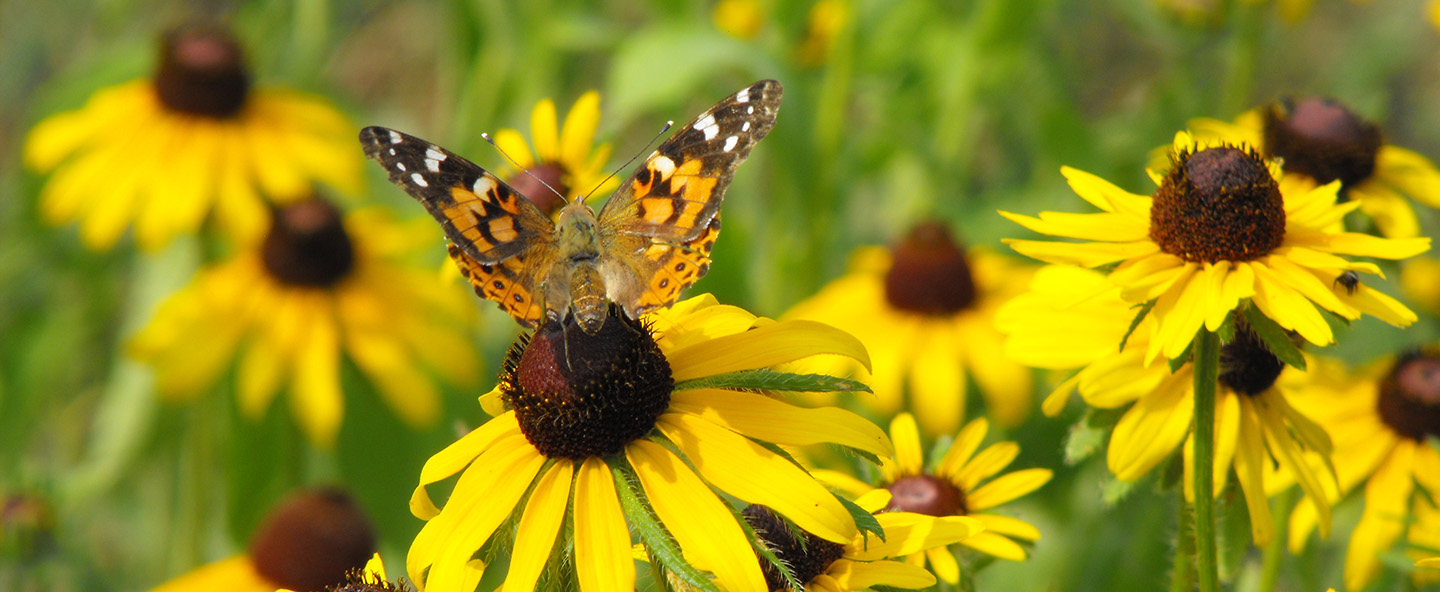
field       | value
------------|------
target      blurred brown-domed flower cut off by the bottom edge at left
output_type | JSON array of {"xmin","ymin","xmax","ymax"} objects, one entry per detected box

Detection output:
[{"xmin": 151, "ymin": 488, "xmax": 376, "ymax": 592}]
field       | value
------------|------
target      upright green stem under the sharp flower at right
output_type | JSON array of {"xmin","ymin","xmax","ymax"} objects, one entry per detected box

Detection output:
[{"xmin": 1191, "ymin": 328, "xmax": 1220, "ymax": 592}]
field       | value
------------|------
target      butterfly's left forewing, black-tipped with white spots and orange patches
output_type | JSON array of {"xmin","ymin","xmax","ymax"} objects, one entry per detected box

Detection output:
[{"xmin": 360, "ymin": 127, "xmax": 554, "ymax": 264}]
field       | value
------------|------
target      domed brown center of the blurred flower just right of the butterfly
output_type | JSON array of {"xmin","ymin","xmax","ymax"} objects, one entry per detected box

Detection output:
[{"xmin": 886, "ymin": 222, "xmax": 975, "ymax": 315}]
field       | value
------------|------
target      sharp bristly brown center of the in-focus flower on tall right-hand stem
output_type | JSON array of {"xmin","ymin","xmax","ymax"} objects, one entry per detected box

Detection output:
[{"xmin": 1151, "ymin": 147, "xmax": 1284, "ymax": 264}]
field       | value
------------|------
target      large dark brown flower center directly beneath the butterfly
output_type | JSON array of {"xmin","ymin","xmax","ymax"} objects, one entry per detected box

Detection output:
[{"xmin": 500, "ymin": 304, "xmax": 675, "ymax": 459}]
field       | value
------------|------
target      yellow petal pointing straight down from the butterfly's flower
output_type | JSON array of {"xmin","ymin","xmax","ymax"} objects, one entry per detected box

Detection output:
[{"xmin": 573, "ymin": 457, "xmax": 635, "ymax": 591}]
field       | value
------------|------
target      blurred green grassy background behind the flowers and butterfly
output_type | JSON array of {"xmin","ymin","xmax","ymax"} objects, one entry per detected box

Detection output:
[{"xmin": 8, "ymin": 0, "xmax": 1440, "ymax": 591}]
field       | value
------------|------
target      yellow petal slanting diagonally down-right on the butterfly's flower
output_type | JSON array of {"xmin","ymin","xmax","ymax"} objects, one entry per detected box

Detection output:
[{"xmin": 655, "ymin": 413, "xmax": 857, "ymax": 543}]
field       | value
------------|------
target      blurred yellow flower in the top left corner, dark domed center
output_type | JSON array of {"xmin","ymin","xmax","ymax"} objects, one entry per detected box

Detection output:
[{"xmin": 24, "ymin": 30, "xmax": 361, "ymax": 251}]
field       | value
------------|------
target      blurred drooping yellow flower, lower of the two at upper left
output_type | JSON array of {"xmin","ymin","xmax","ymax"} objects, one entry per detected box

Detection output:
[{"xmin": 130, "ymin": 199, "xmax": 477, "ymax": 445}]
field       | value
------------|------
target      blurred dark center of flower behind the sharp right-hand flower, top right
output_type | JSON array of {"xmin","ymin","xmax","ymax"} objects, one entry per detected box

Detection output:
[{"xmin": 1263, "ymin": 98, "xmax": 1385, "ymax": 187}]
